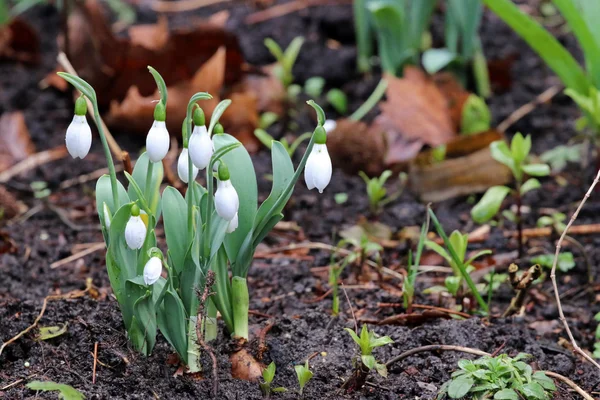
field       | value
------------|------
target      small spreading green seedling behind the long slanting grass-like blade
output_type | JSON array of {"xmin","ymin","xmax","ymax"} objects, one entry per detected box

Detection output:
[{"xmin": 425, "ymin": 231, "xmax": 492, "ymax": 296}]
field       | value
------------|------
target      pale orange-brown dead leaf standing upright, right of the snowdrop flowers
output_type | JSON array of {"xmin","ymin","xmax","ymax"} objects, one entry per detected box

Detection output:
[{"xmin": 373, "ymin": 67, "xmax": 456, "ymax": 165}]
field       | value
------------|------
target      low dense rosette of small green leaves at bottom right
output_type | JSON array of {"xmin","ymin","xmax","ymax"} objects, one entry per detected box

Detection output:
[{"xmin": 437, "ymin": 353, "xmax": 556, "ymax": 400}]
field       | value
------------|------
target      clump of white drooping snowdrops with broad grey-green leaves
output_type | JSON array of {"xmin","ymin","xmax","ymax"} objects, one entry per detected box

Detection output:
[{"xmin": 60, "ymin": 67, "xmax": 332, "ymax": 371}]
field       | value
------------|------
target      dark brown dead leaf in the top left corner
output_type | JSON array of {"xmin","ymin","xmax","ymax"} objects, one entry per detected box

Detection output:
[{"xmin": 0, "ymin": 18, "xmax": 40, "ymax": 64}]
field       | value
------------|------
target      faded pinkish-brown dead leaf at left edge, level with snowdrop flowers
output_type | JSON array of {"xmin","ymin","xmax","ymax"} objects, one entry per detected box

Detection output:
[{"xmin": 0, "ymin": 111, "xmax": 35, "ymax": 172}]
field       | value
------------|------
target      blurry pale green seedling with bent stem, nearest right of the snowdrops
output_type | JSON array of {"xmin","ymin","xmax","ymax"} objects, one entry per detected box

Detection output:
[{"xmin": 329, "ymin": 235, "xmax": 383, "ymax": 316}]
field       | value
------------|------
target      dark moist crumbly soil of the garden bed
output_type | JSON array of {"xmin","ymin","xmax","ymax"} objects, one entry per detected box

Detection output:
[{"xmin": 0, "ymin": 1, "xmax": 600, "ymax": 399}]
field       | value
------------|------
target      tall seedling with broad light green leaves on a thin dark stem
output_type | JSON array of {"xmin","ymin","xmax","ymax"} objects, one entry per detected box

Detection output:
[{"xmin": 471, "ymin": 133, "xmax": 550, "ymax": 257}]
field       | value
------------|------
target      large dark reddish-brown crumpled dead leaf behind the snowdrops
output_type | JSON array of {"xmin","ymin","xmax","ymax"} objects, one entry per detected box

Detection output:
[{"xmin": 69, "ymin": 0, "xmax": 243, "ymax": 107}]
